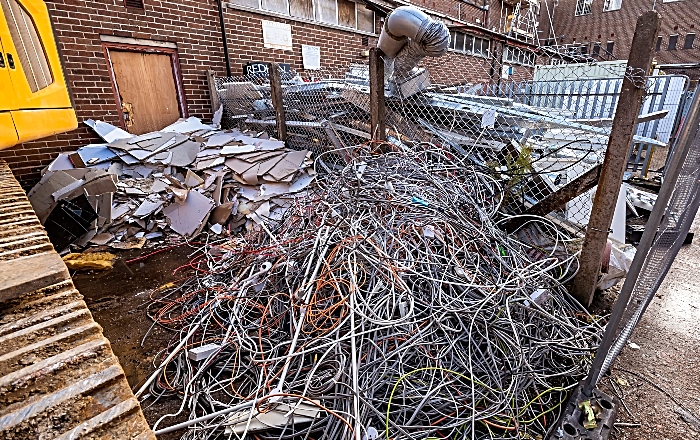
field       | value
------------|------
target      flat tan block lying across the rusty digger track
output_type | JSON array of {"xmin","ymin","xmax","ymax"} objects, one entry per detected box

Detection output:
[{"xmin": 0, "ymin": 252, "xmax": 70, "ymax": 302}]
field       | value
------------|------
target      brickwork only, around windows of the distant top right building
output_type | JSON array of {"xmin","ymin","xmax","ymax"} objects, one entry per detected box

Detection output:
[{"xmin": 540, "ymin": 0, "xmax": 700, "ymax": 63}]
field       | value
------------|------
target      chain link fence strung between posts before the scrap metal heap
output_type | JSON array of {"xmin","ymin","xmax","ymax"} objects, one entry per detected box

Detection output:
[{"xmin": 216, "ymin": 45, "xmax": 689, "ymax": 235}]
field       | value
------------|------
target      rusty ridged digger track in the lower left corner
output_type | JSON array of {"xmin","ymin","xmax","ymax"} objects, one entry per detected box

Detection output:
[{"xmin": 0, "ymin": 161, "xmax": 155, "ymax": 440}]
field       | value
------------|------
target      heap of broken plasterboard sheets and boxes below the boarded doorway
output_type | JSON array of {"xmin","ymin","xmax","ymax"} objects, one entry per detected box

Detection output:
[{"xmin": 29, "ymin": 118, "xmax": 315, "ymax": 251}]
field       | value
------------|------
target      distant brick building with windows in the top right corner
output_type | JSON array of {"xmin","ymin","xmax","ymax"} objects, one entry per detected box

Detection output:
[{"xmin": 540, "ymin": 0, "xmax": 700, "ymax": 67}]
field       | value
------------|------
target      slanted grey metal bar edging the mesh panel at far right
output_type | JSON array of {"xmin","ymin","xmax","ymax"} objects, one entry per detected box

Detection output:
[{"xmin": 583, "ymin": 71, "xmax": 700, "ymax": 396}]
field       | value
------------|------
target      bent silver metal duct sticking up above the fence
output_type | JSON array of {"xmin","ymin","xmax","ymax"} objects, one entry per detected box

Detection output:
[{"xmin": 377, "ymin": 6, "xmax": 450, "ymax": 78}]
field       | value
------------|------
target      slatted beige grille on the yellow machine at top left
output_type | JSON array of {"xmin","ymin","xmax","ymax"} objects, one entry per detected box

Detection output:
[{"xmin": 0, "ymin": 0, "xmax": 53, "ymax": 93}]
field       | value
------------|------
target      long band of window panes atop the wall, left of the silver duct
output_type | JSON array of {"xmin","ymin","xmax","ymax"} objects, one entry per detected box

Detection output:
[{"xmin": 230, "ymin": 0, "xmax": 375, "ymax": 33}]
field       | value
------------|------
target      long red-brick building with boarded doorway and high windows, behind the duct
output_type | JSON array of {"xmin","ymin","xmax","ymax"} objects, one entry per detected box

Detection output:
[{"xmin": 0, "ymin": 0, "xmax": 531, "ymax": 187}]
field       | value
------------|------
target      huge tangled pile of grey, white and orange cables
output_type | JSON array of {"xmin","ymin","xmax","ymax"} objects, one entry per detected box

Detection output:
[{"xmin": 142, "ymin": 144, "xmax": 601, "ymax": 440}]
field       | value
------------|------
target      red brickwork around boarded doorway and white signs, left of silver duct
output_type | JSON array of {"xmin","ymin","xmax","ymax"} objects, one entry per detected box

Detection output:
[{"xmin": 0, "ymin": 0, "xmax": 376, "ymax": 187}]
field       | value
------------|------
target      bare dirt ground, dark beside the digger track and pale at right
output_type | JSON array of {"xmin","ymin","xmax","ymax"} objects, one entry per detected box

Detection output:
[{"xmin": 73, "ymin": 220, "xmax": 700, "ymax": 440}]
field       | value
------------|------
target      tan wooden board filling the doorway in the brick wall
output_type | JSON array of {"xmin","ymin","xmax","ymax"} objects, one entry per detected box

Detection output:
[{"xmin": 109, "ymin": 49, "xmax": 183, "ymax": 134}]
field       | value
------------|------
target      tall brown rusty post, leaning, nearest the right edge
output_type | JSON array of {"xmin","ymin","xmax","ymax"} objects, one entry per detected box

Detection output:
[{"xmin": 571, "ymin": 11, "xmax": 660, "ymax": 307}]
